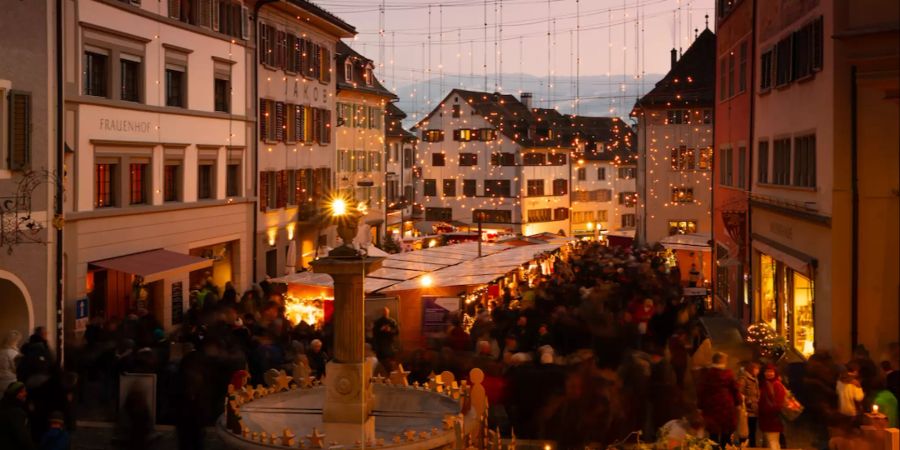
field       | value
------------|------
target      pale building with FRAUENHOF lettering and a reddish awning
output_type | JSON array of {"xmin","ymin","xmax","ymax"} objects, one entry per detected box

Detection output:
[{"xmin": 63, "ymin": 0, "xmax": 254, "ymax": 336}]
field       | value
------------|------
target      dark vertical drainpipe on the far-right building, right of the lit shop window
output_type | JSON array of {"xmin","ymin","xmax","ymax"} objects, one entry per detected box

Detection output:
[{"xmin": 850, "ymin": 65, "xmax": 859, "ymax": 348}]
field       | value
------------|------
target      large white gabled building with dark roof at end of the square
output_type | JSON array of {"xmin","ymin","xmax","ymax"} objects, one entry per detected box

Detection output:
[{"xmin": 415, "ymin": 89, "xmax": 571, "ymax": 238}]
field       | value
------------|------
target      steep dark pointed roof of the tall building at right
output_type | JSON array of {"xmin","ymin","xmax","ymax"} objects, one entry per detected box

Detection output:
[{"xmin": 635, "ymin": 28, "xmax": 716, "ymax": 108}]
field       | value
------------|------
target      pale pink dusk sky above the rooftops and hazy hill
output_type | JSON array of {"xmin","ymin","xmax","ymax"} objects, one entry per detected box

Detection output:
[{"xmin": 313, "ymin": 0, "xmax": 714, "ymax": 96}]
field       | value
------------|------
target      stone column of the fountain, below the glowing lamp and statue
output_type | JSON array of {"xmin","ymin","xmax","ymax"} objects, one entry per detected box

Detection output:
[{"xmin": 311, "ymin": 248, "xmax": 384, "ymax": 428}]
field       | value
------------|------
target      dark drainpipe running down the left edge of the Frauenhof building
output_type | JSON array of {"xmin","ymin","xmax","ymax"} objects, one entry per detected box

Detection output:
[{"xmin": 53, "ymin": 0, "xmax": 65, "ymax": 367}]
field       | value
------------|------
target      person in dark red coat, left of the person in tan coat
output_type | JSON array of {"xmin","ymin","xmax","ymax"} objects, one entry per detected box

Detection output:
[{"xmin": 697, "ymin": 352, "xmax": 740, "ymax": 448}]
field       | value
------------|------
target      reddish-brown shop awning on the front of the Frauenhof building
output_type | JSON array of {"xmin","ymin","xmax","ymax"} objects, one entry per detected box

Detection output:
[{"xmin": 91, "ymin": 249, "xmax": 213, "ymax": 283}]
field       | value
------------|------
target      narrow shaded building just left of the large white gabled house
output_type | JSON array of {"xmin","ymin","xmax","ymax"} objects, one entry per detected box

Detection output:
[{"xmin": 384, "ymin": 103, "xmax": 418, "ymax": 241}]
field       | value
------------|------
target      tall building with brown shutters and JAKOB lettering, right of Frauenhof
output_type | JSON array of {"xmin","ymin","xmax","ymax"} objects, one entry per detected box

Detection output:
[{"xmin": 253, "ymin": 0, "xmax": 356, "ymax": 279}]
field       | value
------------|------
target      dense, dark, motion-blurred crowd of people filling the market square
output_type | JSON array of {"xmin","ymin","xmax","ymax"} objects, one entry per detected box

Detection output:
[{"xmin": 0, "ymin": 242, "xmax": 898, "ymax": 450}]
